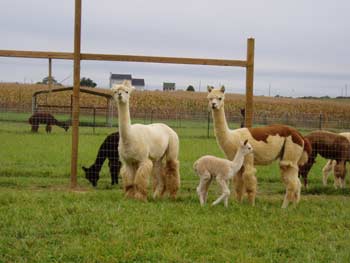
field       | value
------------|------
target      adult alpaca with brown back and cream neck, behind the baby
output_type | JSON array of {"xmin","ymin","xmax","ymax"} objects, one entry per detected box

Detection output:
[{"xmin": 207, "ymin": 86, "xmax": 311, "ymax": 208}]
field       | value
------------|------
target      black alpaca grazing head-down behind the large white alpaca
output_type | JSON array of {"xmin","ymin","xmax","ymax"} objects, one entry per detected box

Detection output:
[{"xmin": 82, "ymin": 132, "xmax": 121, "ymax": 187}]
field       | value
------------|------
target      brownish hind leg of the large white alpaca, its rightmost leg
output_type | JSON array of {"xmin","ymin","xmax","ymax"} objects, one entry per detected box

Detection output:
[{"xmin": 165, "ymin": 160, "xmax": 180, "ymax": 198}]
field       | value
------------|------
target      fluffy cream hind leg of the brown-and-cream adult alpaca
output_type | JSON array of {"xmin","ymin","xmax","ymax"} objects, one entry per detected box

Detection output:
[{"xmin": 280, "ymin": 164, "xmax": 301, "ymax": 208}]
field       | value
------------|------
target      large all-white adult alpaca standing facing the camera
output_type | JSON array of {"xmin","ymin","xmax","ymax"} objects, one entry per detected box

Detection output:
[{"xmin": 112, "ymin": 81, "xmax": 180, "ymax": 201}]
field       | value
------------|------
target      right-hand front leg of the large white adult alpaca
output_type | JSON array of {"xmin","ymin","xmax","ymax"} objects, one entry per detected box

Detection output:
[{"xmin": 134, "ymin": 159, "xmax": 153, "ymax": 201}]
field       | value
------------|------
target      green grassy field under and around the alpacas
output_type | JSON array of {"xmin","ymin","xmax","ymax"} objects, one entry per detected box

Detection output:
[{"xmin": 0, "ymin": 122, "xmax": 350, "ymax": 262}]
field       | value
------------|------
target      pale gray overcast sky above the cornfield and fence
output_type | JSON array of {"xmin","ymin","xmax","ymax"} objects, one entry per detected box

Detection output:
[{"xmin": 0, "ymin": 0, "xmax": 350, "ymax": 96}]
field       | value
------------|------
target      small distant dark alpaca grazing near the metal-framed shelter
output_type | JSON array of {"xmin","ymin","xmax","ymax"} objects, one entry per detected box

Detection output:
[{"xmin": 28, "ymin": 112, "xmax": 69, "ymax": 133}]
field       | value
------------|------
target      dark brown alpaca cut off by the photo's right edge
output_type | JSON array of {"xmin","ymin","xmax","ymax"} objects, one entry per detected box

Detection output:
[{"xmin": 299, "ymin": 131, "xmax": 350, "ymax": 187}]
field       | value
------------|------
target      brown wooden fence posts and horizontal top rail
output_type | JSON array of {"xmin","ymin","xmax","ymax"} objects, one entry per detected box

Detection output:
[{"xmin": 0, "ymin": 0, "xmax": 255, "ymax": 189}]
